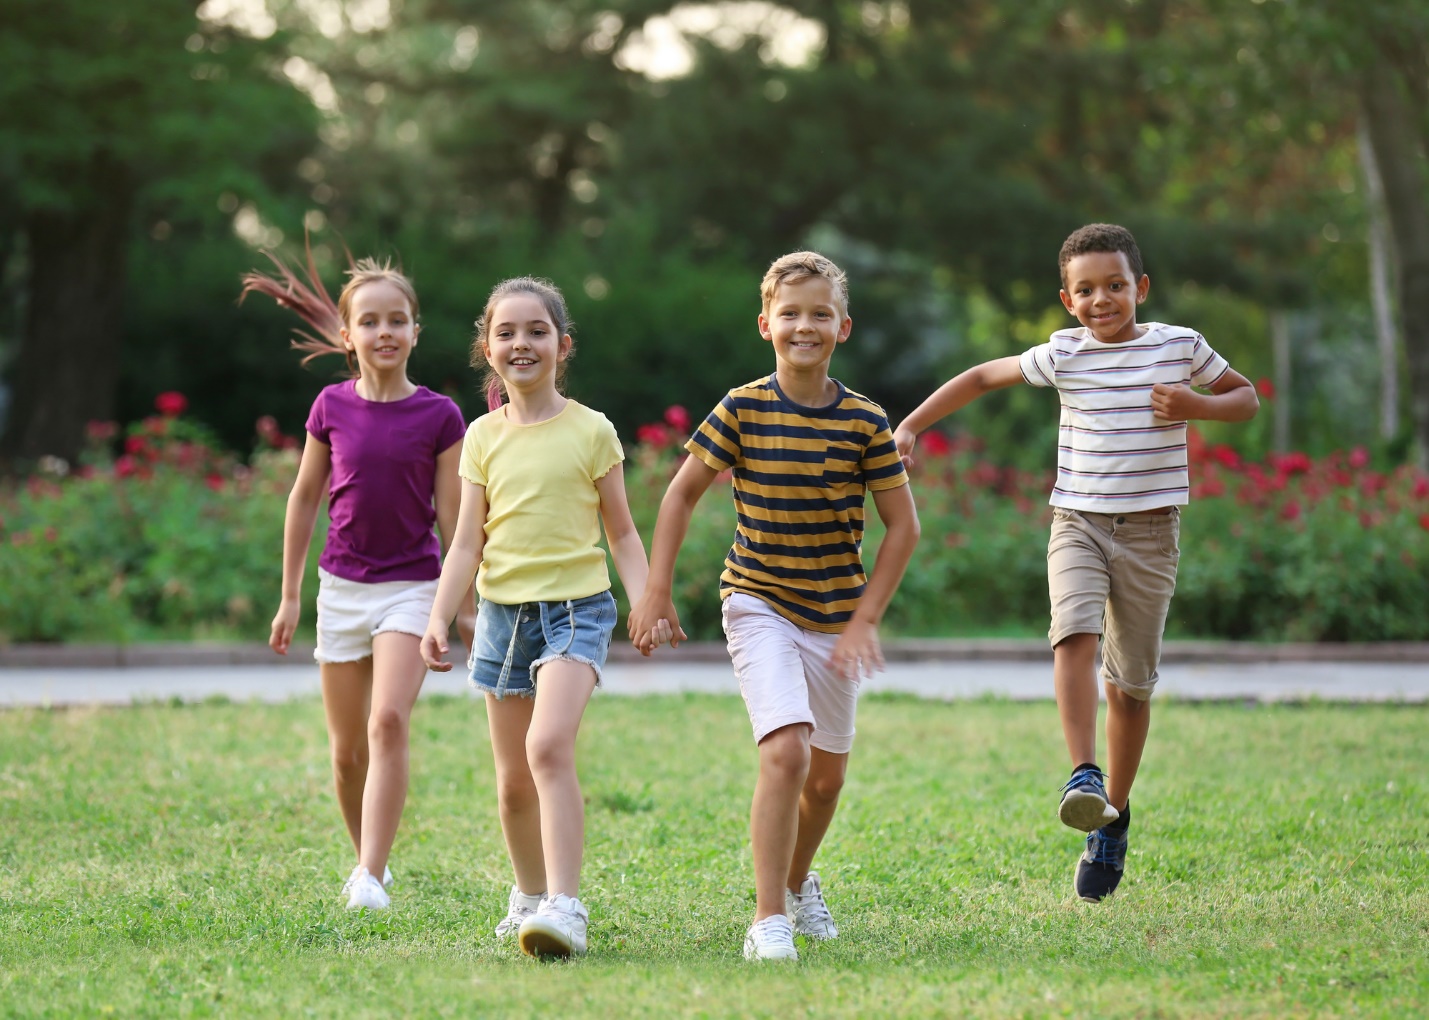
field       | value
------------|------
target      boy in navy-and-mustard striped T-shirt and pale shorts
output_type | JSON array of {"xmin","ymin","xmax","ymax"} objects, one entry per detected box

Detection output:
[{"xmin": 630, "ymin": 251, "xmax": 917, "ymax": 960}]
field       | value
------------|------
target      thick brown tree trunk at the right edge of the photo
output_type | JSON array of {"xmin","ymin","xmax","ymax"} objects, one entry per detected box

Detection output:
[{"xmin": 1360, "ymin": 61, "xmax": 1429, "ymax": 469}]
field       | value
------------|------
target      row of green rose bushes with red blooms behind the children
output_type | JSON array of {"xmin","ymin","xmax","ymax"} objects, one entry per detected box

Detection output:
[{"xmin": 0, "ymin": 394, "xmax": 1429, "ymax": 641}]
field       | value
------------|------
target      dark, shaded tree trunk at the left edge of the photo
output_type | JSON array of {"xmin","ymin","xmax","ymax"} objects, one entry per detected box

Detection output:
[{"xmin": 0, "ymin": 157, "xmax": 133, "ymax": 463}]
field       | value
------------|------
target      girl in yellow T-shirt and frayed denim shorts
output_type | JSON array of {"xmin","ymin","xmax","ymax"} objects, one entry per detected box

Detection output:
[{"xmin": 422, "ymin": 277, "xmax": 665, "ymax": 956}]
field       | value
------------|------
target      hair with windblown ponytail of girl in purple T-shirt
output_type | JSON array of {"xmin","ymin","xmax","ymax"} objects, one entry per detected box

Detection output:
[{"xmin": 239, "ymin": 239, "xmax": 419, "ymax": 379}]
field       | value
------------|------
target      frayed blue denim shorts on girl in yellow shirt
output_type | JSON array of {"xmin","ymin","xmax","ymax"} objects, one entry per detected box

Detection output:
[{"xmin": 466, "ymin": 591, "xmax": 616, "ymax": 699}]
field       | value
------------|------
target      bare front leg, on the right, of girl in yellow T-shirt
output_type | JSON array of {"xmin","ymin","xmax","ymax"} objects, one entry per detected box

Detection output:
[{"xmin": 526, "ymin": 659, "xmax": 596, "ymax": 896}]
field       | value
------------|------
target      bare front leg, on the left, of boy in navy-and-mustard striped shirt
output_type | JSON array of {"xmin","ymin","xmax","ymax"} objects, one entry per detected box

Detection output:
[{"xmin": 749, "ymin": 723, "xmax": 827, "ymax": 921}]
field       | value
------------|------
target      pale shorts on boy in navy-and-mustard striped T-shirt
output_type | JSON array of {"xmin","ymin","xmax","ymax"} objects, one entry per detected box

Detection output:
[{"xmin": 720, "ymin": 591, "xmax": 859, "ymax": 754}]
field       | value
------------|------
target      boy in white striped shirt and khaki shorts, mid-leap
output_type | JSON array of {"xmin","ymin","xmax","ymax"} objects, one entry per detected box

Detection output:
[{"xmin": 895, "ymin": 223, "xmax": 1259, "ymax": 903}]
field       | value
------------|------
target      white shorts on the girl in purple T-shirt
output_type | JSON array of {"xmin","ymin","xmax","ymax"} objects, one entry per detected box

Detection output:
[{"xmin": 313, "ymin": 567, "xmax": 437, "ymax": 663}]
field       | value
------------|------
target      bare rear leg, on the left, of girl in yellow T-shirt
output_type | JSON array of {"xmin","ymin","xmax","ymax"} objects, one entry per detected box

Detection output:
[{"xmin": 486, "ymin": 694, "xmax": 546, "ymax": 896}]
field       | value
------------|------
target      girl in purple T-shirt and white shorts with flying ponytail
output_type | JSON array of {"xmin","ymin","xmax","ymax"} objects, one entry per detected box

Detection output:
[{"xmin": 243, "ymin": 254, "xmax": 473, "ymax": 910}]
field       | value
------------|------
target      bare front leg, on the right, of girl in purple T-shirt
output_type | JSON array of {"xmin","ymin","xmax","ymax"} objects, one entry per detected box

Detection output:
[{"xmin": 359, "ymin": 631, "xmax": 427, "ymax": 881}]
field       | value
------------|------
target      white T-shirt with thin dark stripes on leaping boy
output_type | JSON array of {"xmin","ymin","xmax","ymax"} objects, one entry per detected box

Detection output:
[{"xmin": 1022, "ymin": 323, "xmax": 1230, "ymax": 513}]
